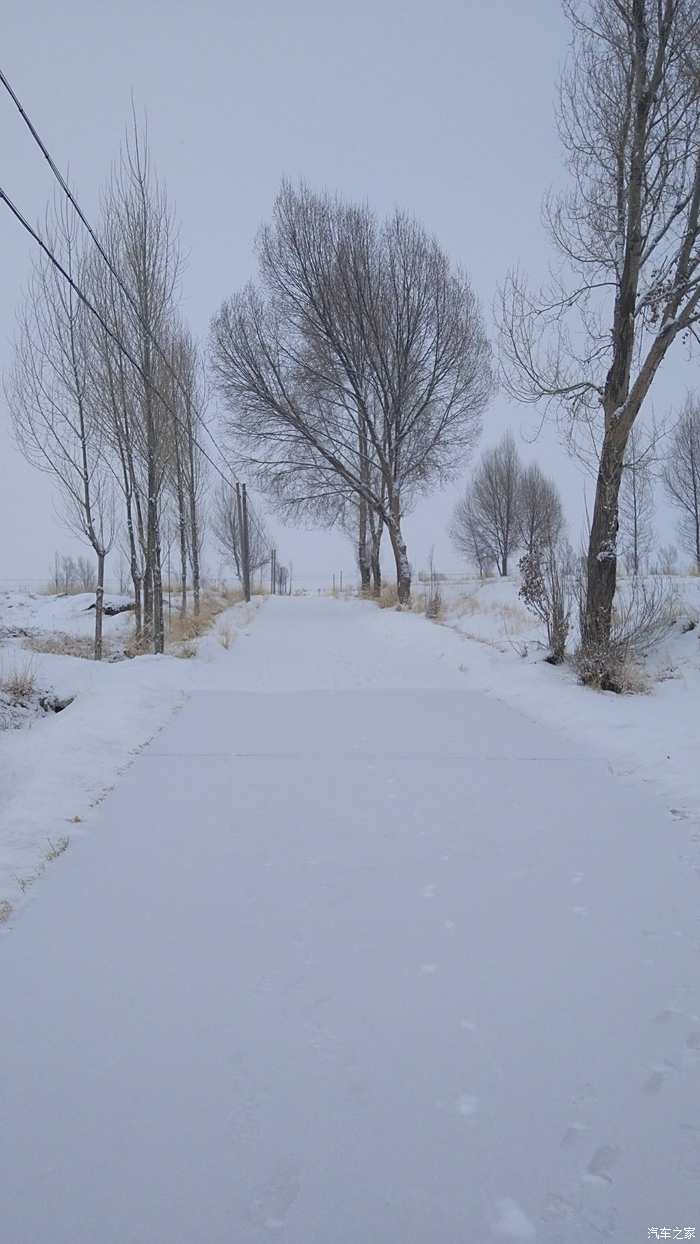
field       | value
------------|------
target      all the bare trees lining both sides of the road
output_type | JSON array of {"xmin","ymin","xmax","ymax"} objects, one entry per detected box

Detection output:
[{"xmin": 10, "ymin": 0, "xmax": 700, "ymax": 680}]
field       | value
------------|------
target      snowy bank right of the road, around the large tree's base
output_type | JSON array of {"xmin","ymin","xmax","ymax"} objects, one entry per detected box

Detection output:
[{"xmin": 437, "ymin": 577, "xmax": 700, "ymax": 817}]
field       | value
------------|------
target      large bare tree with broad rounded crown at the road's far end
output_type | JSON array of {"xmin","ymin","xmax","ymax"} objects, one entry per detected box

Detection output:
[{"xmin": 211, "ymin": 184, "xmax": 492, "ymax": 601}]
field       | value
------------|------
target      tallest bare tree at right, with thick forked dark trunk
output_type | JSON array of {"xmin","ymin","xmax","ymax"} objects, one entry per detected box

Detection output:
[{"xmin": 501, "ymin": 0, "xmax": 700, "ymax": 681}]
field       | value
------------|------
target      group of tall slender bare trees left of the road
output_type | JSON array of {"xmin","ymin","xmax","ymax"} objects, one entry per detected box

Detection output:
[{"xmin": 5, "ymin": 118, "xmax": 279, "ymax": 659}]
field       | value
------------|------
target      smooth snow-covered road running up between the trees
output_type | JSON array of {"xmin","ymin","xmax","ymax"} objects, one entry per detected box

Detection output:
[{"xmin": 0, "ymin": 600, "xmax": 700, "ymax": 1244}]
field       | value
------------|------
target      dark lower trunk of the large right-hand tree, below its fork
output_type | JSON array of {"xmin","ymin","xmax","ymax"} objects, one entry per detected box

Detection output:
[{"xmin": 582, "ymin": 428, "xmax": 627, "ymax": 656}]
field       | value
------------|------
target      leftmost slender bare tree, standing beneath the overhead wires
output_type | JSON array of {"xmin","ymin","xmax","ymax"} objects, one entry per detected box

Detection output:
[{"xmin": 6, "ymin": 205, "xmax": 114, "ymax": 661}]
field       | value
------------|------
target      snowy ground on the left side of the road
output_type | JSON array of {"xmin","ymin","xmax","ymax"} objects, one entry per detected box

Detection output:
[{"xmin": 0, "ymin": 593, "xmax": 259, "ymax": 913}]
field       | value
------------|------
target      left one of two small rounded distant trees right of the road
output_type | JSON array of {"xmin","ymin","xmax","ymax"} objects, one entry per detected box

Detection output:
[{"xmin": 457, "ymin": 432, "xmax": 522, "ymax": 576}]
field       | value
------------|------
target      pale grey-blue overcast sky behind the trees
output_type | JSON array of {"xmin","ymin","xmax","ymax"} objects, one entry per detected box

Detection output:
[{"xmin": 0, "ymin": 0, "xmax": 689, "ymax": 586}]
